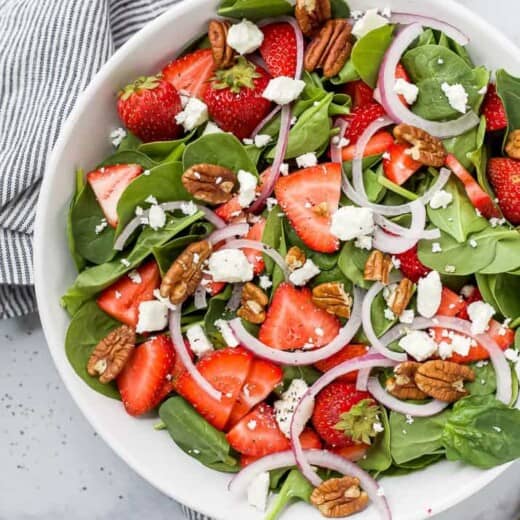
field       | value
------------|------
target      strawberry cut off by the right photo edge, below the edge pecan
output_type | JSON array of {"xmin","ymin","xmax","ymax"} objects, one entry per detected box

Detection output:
[{"xmin": 488, "ymin": 157, "xmax": 520, "ymax": 226}]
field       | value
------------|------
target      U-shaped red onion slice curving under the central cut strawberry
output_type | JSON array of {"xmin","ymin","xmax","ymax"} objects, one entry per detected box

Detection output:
[{"xmin": 229, "ymin": 288, "xmax": 363, "ymax": 366}]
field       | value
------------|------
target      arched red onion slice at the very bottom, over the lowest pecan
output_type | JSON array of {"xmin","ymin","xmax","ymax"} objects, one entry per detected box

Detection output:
[{"xmin": 229, "ymin": 450, "xmax": 392, "ymax": 520}]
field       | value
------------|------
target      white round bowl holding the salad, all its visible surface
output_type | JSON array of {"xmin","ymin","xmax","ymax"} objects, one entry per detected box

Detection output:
[{"xmin": 34, "ymin": 0, "xmax": 520, "ymax": 520}]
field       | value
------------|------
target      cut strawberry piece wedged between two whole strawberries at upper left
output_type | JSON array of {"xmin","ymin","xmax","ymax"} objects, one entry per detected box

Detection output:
[{"xmin": 162, "ymin": 49, "xmax": 215, "ymax": 99}]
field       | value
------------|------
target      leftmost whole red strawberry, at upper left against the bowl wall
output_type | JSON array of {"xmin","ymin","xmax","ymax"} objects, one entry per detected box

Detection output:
[{"xmin": 117, "ymin": 76, "xmax": 183, "ymax": 142}]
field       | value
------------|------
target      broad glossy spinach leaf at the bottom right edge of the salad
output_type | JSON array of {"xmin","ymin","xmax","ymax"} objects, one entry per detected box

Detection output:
[{"xmin": 441, "ymin": 395, "xmax": 520, "ymax": 469}]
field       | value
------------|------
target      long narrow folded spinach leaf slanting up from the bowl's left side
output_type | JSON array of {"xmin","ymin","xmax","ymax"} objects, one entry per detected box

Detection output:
[{"xmin": 61, "ymin": 212, "xmax": 203, "ymax": 315}]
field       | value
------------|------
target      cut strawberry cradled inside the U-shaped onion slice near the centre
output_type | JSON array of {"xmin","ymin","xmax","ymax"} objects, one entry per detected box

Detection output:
[{"xmin": 258, "ymin": 283, "xmax": 340, "ymax": 350}]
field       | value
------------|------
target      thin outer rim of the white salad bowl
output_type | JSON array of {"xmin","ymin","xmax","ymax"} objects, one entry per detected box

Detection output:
[{"xmin": 33, "ymin": 0, "xmax": 520, "ymax": 520}]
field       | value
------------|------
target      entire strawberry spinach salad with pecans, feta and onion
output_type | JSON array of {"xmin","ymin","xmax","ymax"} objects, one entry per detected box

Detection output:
[{"xmin": 61, "ymin": 0, "xmax": 520, "ymax": 519}]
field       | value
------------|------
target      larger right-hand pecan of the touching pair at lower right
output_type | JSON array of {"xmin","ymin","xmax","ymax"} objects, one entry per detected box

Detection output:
[{"xmin": 415, "ymin": 360, "xmax": 475, "ymax": 403}]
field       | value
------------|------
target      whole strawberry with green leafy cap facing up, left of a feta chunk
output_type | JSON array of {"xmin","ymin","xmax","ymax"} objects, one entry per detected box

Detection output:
[{"xmin": 204, "ymin": 57, "xmax": 271, "ymax": 139}]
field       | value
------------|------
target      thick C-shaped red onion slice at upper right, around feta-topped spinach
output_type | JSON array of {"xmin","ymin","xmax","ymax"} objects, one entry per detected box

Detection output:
[{"xmin": 378, "ymin": 23, "xmax": 480, "ymax": 139}]
